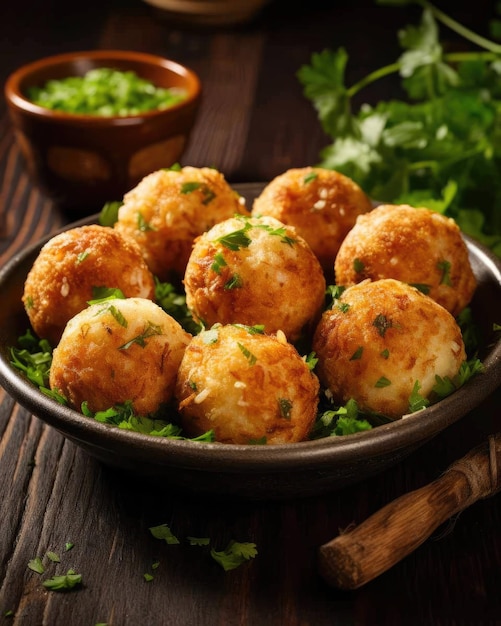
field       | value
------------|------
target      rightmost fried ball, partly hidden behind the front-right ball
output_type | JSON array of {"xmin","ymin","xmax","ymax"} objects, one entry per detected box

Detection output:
[{"xmin": 335, "ymin": 204, "xmax": 476, "ymax": 316}]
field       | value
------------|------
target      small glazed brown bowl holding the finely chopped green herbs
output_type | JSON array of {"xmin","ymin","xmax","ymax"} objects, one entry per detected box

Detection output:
[{"xmin": 5, "ymin": 50, "xmax": 201, "ymax": 215}]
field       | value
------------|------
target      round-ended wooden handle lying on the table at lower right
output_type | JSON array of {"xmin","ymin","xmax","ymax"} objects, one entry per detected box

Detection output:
[{"xmin": 319, "ymin": 433, "xmax": 501, "ymax": 589}]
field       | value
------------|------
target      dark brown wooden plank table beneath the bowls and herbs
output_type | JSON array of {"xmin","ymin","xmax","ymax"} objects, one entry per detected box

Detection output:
[{"xmin": 0, "ymin": 0, "xmax": 501, "ymax": 626}]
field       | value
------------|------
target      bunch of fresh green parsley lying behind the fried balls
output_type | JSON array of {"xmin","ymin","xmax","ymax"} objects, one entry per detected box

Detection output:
[{"xmin": 297, "ymin": 0, "xmax": 501, "ymax": 255}]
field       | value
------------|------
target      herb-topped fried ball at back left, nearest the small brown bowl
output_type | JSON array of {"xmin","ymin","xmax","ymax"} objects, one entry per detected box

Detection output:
[{"xmin": 115, "ymin": 166, "xmax": 248, "ymax": 281}]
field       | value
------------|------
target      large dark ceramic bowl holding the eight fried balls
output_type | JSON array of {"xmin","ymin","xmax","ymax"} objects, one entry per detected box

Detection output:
[{"xmin": 0, "ymin": 185, "xmax": 501, "ymax": 499}]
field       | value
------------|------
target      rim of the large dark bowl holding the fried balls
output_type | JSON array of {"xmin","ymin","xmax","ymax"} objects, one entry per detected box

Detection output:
[{"xmin": 0, "ymin": 200, "xmax": 501, "ymax": 473}]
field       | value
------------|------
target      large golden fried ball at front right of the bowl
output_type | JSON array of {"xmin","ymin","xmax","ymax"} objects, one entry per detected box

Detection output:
[{"xmin": 312, "ymin": 278, "xmax": 466, "ymax": 419}]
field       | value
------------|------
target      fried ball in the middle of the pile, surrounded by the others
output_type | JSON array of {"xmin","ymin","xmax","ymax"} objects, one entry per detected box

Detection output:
[{"xmin": 184, "ymin": 216, "xmax": 326, "ymax": 341}]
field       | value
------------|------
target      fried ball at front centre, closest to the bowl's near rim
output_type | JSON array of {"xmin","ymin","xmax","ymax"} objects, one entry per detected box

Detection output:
[{"xmin": 175, "ymin": 325, "xmax": 319, "ymax": 444}]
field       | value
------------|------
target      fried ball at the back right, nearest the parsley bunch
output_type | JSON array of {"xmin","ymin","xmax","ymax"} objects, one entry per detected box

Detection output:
[{"xmin": 252, "ymin": 167, "xmax": 372, "ymax": 274}]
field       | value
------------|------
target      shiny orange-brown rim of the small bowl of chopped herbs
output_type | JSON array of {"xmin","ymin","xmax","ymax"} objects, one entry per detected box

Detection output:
[{"xmin": 4, "ymin": 49, "xmax": 202, "ymax": 124}]
